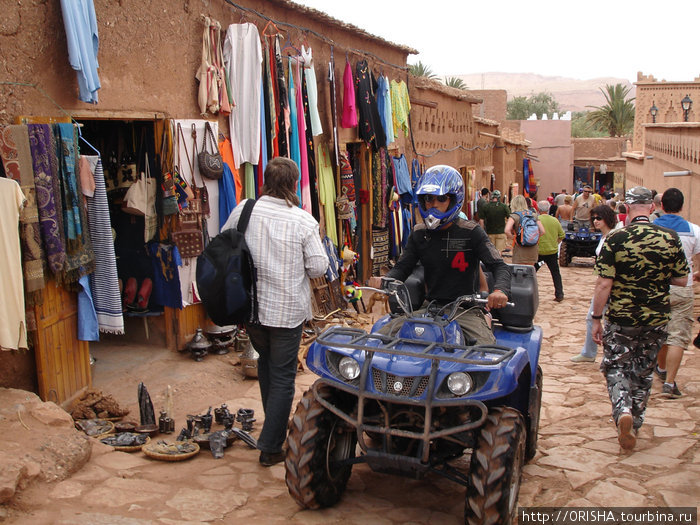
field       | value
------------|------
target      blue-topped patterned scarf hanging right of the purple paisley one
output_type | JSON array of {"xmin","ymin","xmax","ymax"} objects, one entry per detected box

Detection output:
[{"xmin": 54, "ymin": 124, "xmax": 95, "ymax": 283}]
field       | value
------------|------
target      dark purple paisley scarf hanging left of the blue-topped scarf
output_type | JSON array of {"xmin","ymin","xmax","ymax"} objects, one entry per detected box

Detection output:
[{"xmin": 27, "ymin": 124, "xmax": 66, "ymax": 276}]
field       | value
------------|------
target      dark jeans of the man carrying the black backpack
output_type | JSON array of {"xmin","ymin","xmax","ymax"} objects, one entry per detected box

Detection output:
[{"xmin": 246, "ymin": 324, "xmax": 303, "ymax": 454}]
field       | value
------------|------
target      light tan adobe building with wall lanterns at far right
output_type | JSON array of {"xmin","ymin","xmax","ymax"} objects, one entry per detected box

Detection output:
[{"xmin": 622, "ymin": 72, "xmax": 700, "ymax": 224}]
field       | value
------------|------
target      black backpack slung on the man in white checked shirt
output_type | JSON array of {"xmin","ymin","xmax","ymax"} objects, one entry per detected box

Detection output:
[{"xmin": 197, "ymin": 199, "xmax": 259, "ymax": 326}]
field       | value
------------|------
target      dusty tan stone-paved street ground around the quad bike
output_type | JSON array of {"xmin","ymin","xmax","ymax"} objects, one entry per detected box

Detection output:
[{"xmin": 6, "ymin": 264, "xmax": 700, "ymax": 525}]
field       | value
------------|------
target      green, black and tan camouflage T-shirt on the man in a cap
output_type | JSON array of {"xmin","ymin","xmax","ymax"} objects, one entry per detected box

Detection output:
[{"xmin": 595, "ymin": 223, "xmax": 688, "ymax": 327}]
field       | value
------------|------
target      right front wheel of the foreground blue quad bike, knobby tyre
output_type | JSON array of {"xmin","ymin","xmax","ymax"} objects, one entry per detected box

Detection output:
[{"xmin": 464, "ymin": 407, "xmax": 525, "ymax": 525}]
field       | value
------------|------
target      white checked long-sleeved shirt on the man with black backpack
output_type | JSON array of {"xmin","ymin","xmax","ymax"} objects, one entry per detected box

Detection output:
[{"xmin": 221, "ymin": 195, "xmax": 328, "ymax": 328}]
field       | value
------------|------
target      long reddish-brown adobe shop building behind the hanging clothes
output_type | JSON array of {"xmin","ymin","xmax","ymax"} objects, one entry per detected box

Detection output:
[{"xmin": 0, "ymin": 0, "xmax": 525, "ymax": 403}]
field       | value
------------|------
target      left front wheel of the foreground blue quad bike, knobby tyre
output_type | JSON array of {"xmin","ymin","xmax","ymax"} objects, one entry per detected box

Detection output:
[{"xmin": 285, "ymin": 389, "xmax": 357, "ymax": 509}]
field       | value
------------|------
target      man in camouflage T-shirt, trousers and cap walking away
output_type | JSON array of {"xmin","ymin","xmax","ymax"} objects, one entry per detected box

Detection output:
[{"xmin": 592, "ymin": 186, "xmax": 688, "ymax": 450}]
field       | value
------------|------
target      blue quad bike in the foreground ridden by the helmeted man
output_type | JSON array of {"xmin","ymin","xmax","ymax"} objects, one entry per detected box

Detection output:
[{"xmin": 285, "ymin": 265, "xmax": 542, "ymax": 524}]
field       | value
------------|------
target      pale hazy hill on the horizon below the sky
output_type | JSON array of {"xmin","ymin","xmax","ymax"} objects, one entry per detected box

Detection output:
[{"xmin": 450, "ymin": 73, "xmax": 635, "ymax": 111}]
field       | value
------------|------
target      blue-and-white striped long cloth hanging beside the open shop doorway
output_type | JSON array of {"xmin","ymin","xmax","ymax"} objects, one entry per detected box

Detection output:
[{"xmin": 83, "ymin": 156, "xmax": 124, "ymax": 334}]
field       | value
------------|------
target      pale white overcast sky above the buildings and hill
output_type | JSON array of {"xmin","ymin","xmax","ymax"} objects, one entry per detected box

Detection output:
[{"xmin": 294, "ymin": 0, "xmax": 700, "ymax": 82}]
